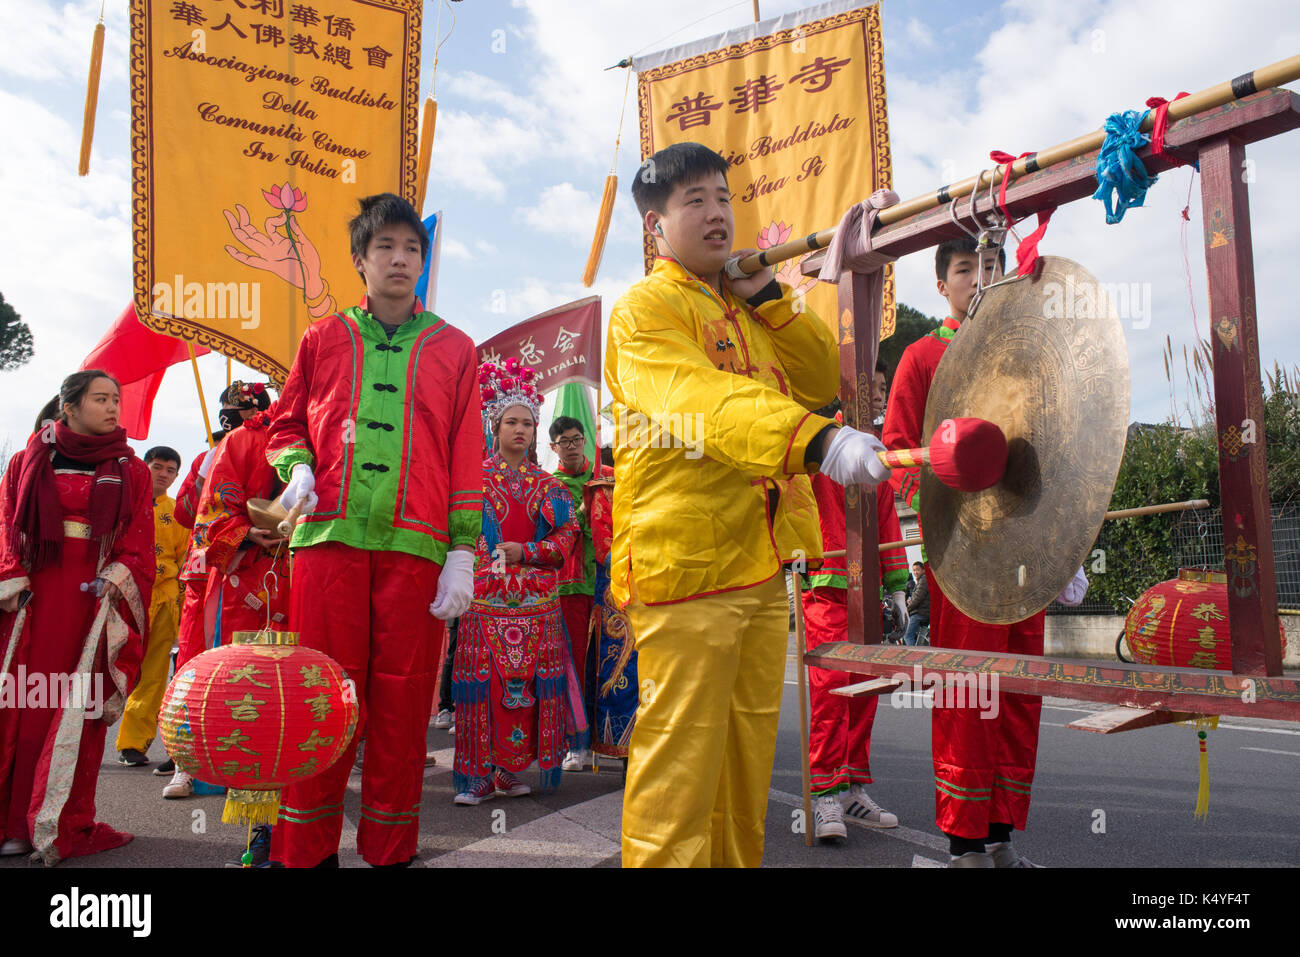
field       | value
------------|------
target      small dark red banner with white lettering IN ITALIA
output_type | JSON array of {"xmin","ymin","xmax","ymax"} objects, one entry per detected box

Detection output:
[{"xmin": 478, "ymin": 295, "xmax": 601, "ymax": 393}]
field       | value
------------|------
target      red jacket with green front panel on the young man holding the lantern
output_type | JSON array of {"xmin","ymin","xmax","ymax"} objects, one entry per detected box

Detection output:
[{"xmin": 267, "ymin": 298, "xmax": 482, "ymax": 564}]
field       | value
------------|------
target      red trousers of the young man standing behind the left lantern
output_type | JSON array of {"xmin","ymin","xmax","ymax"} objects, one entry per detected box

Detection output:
[{"xmin": 272, "ymin": 542, "xmax": 445, "ymax": 867}]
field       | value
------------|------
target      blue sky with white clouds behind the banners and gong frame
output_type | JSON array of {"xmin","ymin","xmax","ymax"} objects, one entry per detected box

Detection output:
[{"xmin": 0, "ymin": 0, "xmax": 1300, "ymax": 470}]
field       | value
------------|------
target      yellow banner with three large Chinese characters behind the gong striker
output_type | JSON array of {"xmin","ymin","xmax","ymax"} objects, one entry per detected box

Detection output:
[{"xmin": 632, "ymin": 1, "xmax": 894, "ymax": 342}]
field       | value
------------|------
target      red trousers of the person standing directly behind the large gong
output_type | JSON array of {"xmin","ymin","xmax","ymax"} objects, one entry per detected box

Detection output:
[{"xmin": 926, "ymin": 566, "xmax": 1044, "ymax": 840}]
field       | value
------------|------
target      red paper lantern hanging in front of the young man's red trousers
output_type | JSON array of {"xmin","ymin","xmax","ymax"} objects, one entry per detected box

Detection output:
[{"xmin": 159, "ymin": 645, "xmax": 358, "ymax": 791}]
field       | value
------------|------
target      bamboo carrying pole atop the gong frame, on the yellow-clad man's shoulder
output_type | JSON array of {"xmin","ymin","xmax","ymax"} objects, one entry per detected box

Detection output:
[{"xmin": 738, "ymin": 55, "xmax": 1300, "ymax": 274}]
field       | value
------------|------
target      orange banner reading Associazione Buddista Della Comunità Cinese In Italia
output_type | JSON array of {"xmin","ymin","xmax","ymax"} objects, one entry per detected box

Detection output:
[{"xmin": 131, "ymin": 0, "xmax": 423, "ymax": 378}]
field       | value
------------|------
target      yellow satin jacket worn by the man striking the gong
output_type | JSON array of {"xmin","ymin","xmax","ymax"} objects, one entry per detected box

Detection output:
[{"xmin": 605, "ymin": 259, "xmax": 840, "ymax": 605}]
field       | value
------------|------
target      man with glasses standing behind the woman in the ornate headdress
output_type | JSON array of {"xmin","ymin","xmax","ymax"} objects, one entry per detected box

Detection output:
[{"xmin": 550, "ymin": 415, "xmax": 614, "ymax": 771}]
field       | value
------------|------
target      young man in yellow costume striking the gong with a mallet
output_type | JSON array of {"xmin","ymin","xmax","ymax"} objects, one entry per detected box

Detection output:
[{"xmin": 605, "ymin": 143, "xmax": 888, "ymax": 867}]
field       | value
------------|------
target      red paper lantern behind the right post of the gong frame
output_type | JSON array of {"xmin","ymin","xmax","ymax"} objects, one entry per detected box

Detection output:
[{"xmin": 1125, "ymin": 568, "xmax": 1286, "ymax": 671}]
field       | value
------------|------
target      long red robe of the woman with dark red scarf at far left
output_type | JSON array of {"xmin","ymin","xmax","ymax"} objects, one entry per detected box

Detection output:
[{"xmin": 0, "ymin": 424, "xmax": 155, "ymax": 865}]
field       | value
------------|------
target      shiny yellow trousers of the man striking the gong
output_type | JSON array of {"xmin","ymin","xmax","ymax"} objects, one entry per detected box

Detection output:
[{"xmin": 623, "ymin": 575, "xmax": 789, "ymax": 867}]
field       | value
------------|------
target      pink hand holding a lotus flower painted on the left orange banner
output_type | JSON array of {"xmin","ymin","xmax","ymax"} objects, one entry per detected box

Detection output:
[{"xmin": 221, "ymin": 183, "xmax": 334, "ymax": 320}]
